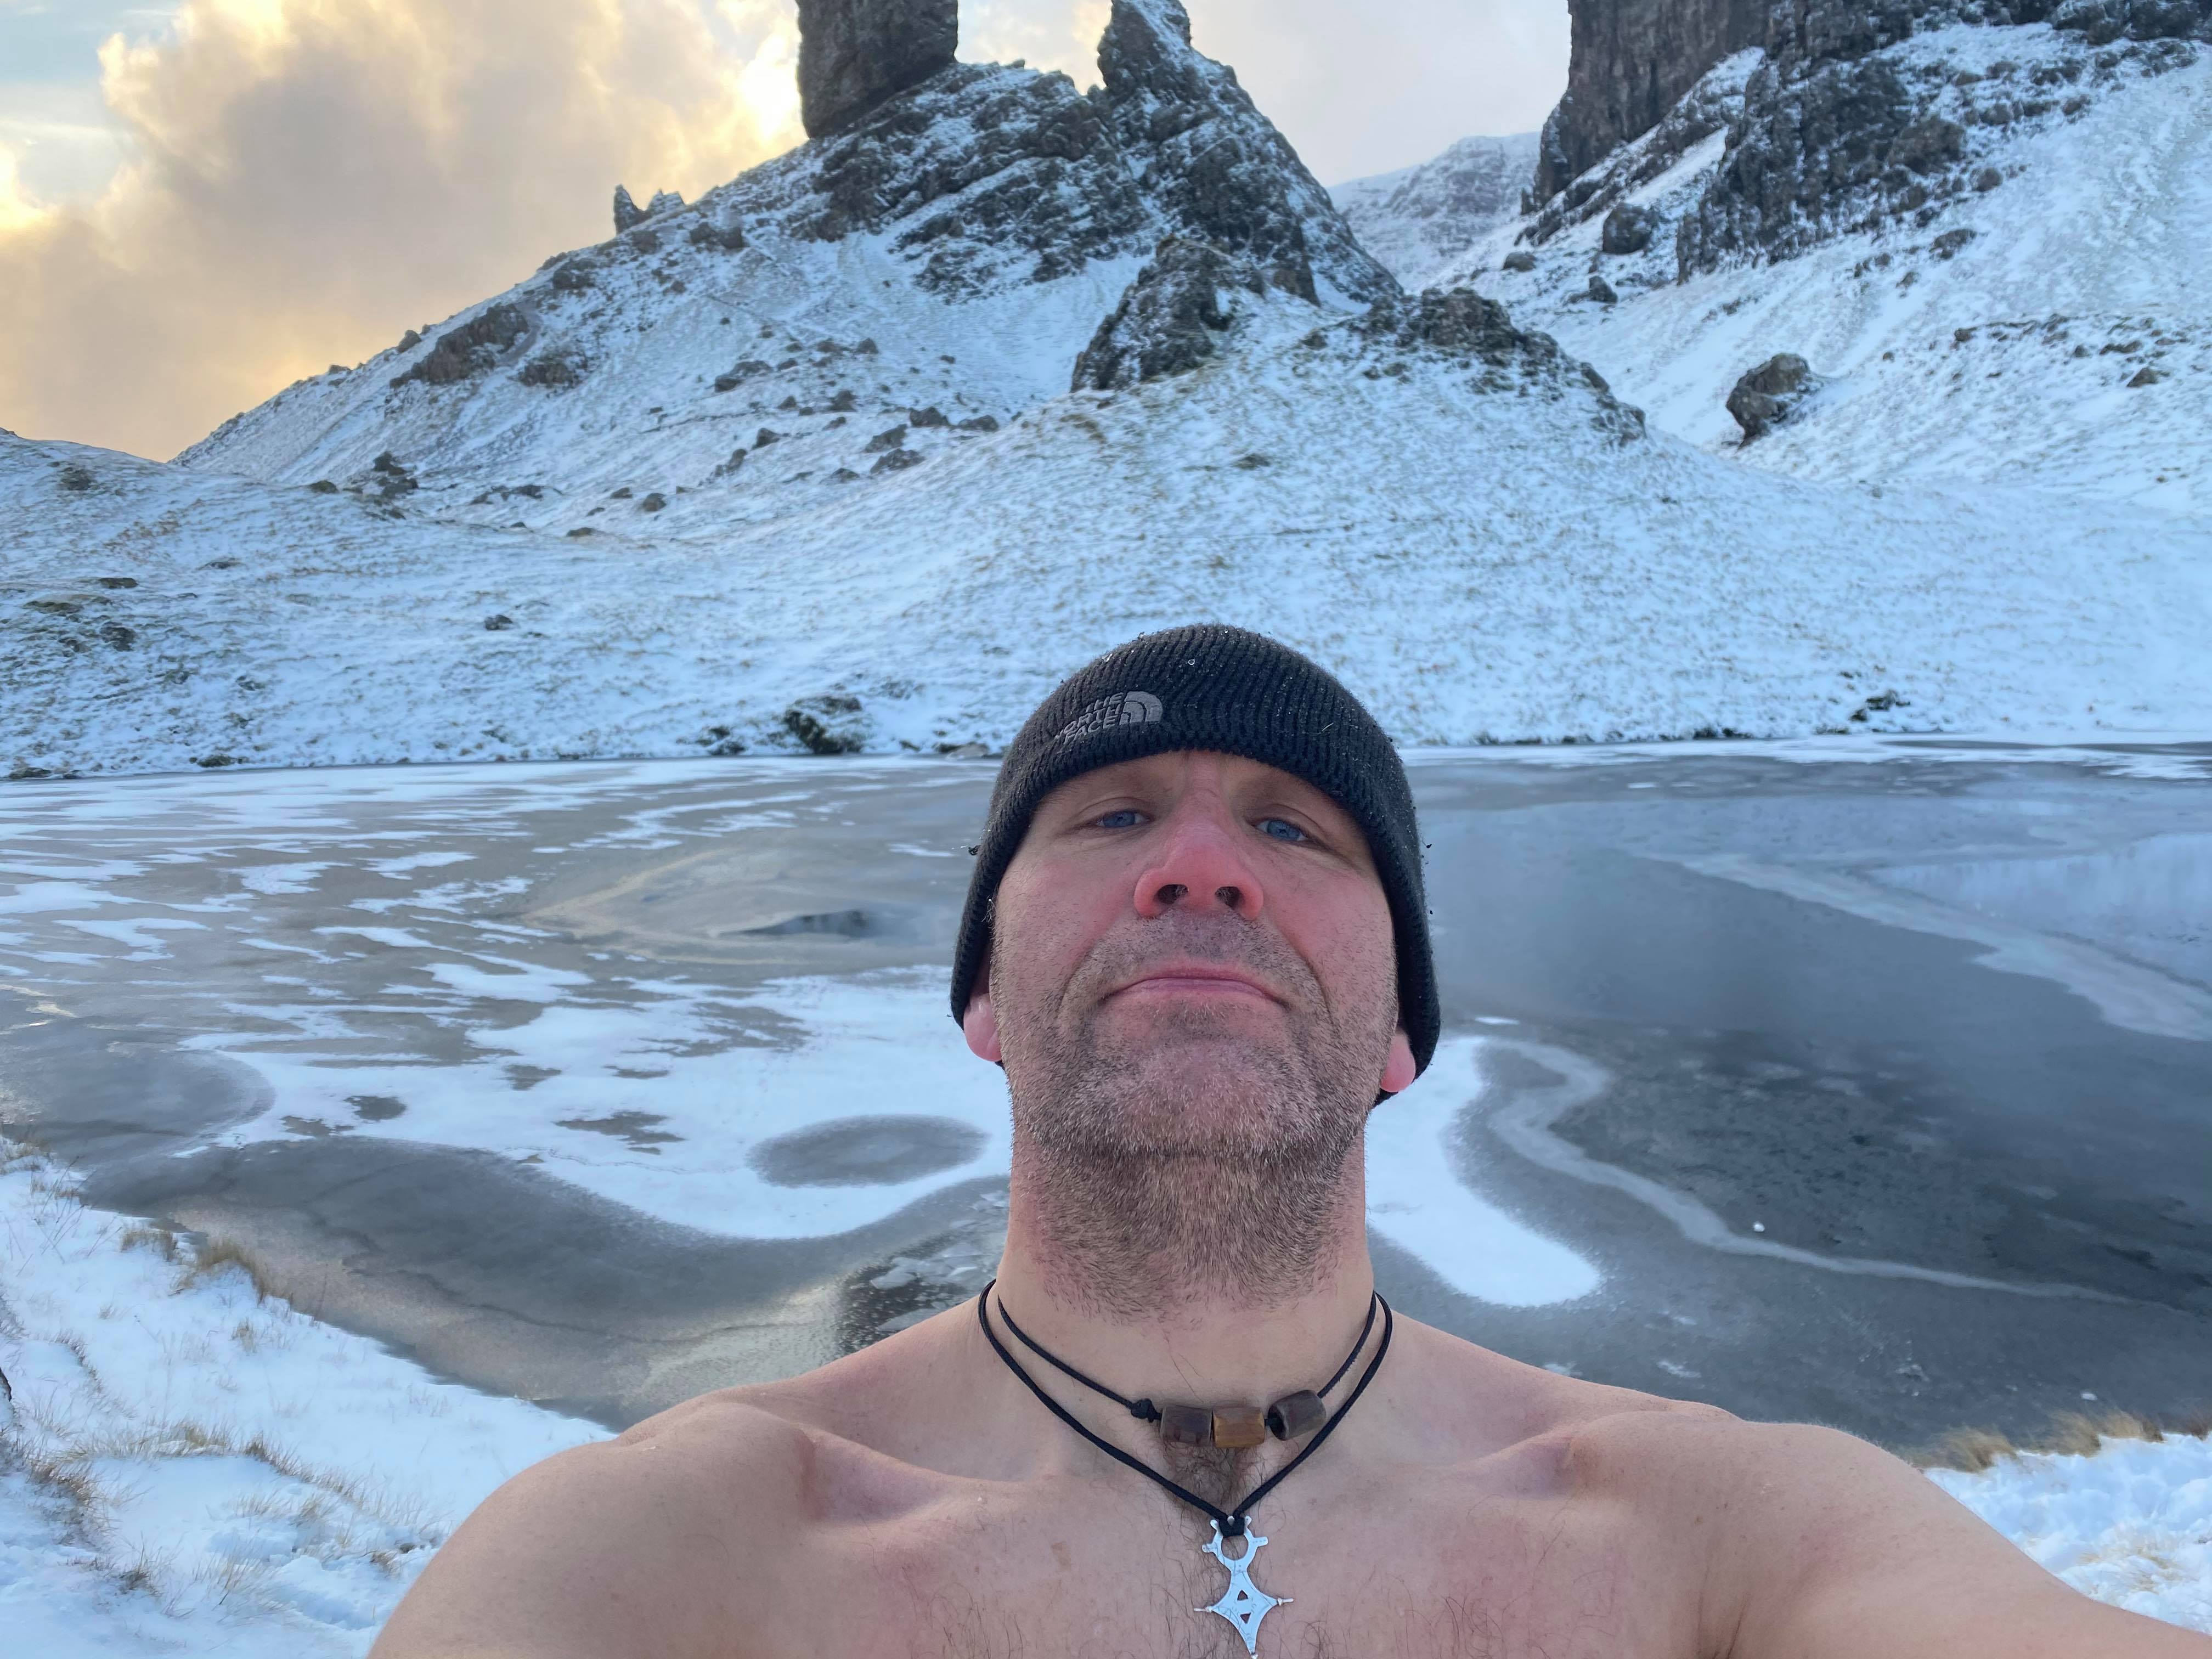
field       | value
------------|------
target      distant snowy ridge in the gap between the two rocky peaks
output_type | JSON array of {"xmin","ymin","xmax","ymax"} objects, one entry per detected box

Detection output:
[{"xmin": 1329, "ymin": 133, "xmax": 1537, "ymax": 292}]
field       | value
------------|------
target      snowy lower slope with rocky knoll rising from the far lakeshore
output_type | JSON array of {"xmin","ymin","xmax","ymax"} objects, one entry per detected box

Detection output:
[{"xmin": 0, "ymin": 273, "xmax": 2212, "ymax": 770}]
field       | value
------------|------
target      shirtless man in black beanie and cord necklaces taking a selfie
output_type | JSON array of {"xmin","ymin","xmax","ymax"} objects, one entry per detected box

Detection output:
[{"xmin": 374, "ymin": 628, "xmax": 2212, "ymax": 1659}]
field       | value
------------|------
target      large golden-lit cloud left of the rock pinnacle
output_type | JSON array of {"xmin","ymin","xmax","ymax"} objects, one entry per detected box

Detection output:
[{"xmin": 0, "ymin": 0, "xmax": 799, "ymax": 456}]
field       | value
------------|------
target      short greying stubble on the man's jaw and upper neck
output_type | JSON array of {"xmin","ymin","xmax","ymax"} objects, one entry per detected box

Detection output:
[{"xmin": 991, "ymin": 916, "xmax": 1396, "ymax": 1323}]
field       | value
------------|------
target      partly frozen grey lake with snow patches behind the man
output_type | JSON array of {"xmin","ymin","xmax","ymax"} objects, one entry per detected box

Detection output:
[{"xmin": 0, "ymin": 739, "xmax": 2212, "ymax": 1444}]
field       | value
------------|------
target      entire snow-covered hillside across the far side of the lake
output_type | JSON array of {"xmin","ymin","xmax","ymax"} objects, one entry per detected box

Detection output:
[{"xmin": 0, "ymin": 0, "xmax": 2212, "ymax": 774}]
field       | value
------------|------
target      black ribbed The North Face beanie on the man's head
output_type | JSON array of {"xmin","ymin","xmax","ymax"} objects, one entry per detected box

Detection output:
[{"xmin": 953, "ymin": 624, "xmax": 1440, "ymax": 1070}]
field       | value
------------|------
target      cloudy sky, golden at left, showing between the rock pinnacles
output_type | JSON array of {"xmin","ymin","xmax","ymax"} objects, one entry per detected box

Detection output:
[{"xmin": 0, "ymin": 0, "xmax": 1566, "ymax": 460}]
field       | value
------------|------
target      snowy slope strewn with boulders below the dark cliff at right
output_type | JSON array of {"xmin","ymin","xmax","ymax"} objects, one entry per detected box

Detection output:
[{"xmin": 1460, "ymin": 24, "xmax": 2212, "ymax": 513}]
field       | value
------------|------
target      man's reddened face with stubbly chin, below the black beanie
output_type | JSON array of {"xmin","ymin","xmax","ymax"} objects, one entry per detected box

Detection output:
[{"xmin": 967, "ymin": 752, "xmax": 1413, "ymax": 1161}]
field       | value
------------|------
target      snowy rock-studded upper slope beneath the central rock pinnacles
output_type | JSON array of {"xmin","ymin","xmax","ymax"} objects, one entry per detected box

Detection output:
[{"xmin": 179, "ymin": 0, "xmax": 1396, "ymax": 531}]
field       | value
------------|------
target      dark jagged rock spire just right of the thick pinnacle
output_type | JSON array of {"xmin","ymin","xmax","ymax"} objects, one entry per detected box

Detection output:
[{"xmin": 1099, "ymin": 0, "xmax": 1398, "ymax": 301}]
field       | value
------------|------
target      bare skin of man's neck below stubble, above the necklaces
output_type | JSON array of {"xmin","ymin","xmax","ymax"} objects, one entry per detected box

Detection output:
[{"xmin": 993, "ymin": 1148, "xmax": 1374, "ymax": 1404}]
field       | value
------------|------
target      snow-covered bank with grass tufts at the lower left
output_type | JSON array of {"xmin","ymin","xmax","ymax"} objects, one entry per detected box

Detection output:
[{"xmin": 0, "ymin": 1142, "xmax": 604, "ymax": 1659}]
